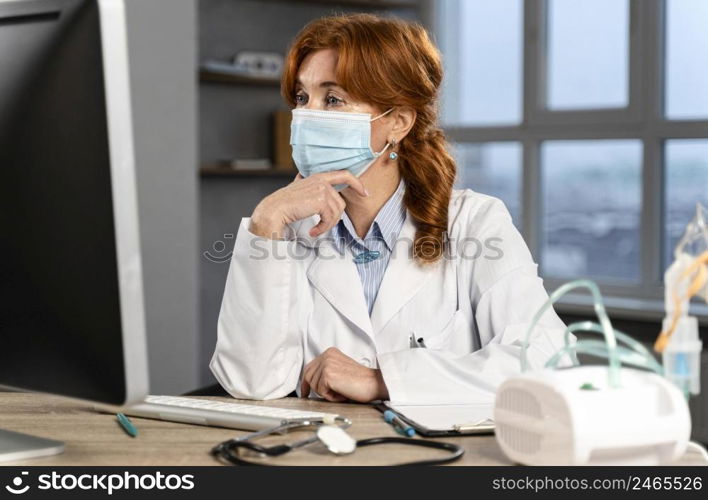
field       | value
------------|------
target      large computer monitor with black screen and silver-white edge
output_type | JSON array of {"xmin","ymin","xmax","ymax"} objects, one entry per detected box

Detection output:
[{"xmin": 0, "ymin": 0, "xmax": 148, "ymax": 456}]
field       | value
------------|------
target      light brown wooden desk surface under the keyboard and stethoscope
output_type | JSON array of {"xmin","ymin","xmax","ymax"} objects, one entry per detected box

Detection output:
[{"xmin": 0, "ymin": 393, "xmax": 704, "ymax": 466}]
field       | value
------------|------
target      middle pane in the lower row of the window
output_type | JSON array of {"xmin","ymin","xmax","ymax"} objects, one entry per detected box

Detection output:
[{"xmin": 541, "ymin": 140, "xmax": 642, "ymax": 281}]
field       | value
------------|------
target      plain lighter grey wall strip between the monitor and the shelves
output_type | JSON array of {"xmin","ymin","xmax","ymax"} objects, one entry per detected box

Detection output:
[{"xmin": 126, "ymin": 0, "xmax": 199, "ymax": 394}]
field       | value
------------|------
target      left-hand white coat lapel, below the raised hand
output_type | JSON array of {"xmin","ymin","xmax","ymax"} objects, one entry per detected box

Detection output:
[{"xmin": 307, "ymin": 227, "xmax": 373, "ymax": 338}]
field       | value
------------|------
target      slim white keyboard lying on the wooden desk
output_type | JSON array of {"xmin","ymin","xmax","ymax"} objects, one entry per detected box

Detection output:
[{"xmin": 123, "ymin": 396, "xmax": 338, "ymax": 431}]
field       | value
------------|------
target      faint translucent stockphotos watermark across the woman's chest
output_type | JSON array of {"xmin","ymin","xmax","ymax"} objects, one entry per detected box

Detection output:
[{"xmin": 202, "ymin": 233, "xmax": 504, "ymax": 264}]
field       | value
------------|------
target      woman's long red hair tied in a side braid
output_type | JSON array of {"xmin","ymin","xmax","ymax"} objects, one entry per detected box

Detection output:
[{"xmin": 281, "ymin": 14, "xmax": 456, "ymax": 263}]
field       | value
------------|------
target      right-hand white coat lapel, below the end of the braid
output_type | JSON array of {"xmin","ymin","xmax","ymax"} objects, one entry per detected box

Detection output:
[{"xmin": 371, "ymin": 214, "xmax": 435, "ymax": 333}]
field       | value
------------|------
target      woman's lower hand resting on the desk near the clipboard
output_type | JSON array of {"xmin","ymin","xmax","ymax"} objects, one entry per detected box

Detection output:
[{"xmin": 300, "ymin": 347, "xmax": 388, "ymax": 403}]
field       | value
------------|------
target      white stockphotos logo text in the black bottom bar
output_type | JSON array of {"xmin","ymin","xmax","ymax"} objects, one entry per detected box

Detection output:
[{"xmin": 5, "ymin": 471, "xmax": 194, "ymax": 496}]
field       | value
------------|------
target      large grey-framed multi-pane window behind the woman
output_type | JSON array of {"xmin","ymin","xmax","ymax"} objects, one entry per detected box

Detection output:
[{"xmin": 433, "ymin": 0, "xmax": 708, "ymax": 306}]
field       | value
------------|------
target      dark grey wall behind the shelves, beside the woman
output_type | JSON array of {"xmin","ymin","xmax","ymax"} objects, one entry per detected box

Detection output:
[{"xmin": 199, "ymin": 0, "xmax": 417, "ymax": 385}]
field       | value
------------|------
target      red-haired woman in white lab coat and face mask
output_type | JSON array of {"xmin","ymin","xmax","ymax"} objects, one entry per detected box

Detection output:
[{"xmin": 210, "ymin": 15, "xmax": 564, "ymax": 404}]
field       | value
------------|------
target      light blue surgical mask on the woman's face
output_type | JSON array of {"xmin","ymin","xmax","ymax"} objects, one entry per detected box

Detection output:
[{"xmin": 290, "ymin": 108, "xmax": 393, "ymax": 190}]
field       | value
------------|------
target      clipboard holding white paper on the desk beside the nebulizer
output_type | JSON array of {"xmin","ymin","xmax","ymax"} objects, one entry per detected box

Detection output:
[{"xmin": 374, "ymin": 401, "xmax": 494, "ymax": 437}]
